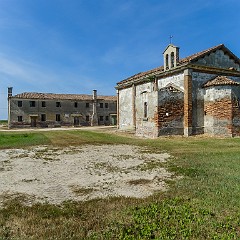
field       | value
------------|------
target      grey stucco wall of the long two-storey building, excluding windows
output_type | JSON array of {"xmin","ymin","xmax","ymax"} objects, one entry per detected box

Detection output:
[{"xmin": 9, "ymin": 97, "xmax": 117, "ymax": 127}]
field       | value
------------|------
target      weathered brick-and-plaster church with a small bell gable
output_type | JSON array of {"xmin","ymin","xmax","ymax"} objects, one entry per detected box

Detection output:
[{"xmin": 116, "ymin": 44, "xmax": 240, "ymax": 137}]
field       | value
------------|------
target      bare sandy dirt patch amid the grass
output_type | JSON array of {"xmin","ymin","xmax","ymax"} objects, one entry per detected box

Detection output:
[{"xmin": 0, "ymin": 145, "xmax": 172, "ymax": 205}]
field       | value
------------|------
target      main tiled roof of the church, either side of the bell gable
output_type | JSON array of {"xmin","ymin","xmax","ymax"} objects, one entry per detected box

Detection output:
[{"xmin": 117, "ymin": 44, "xmax": 240, "ymax": 84}]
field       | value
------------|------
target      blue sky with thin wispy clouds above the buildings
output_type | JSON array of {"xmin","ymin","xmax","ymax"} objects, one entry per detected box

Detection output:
[{"xmin": 0, "ymin": 0, "xmax": 240, "ymax": 119}]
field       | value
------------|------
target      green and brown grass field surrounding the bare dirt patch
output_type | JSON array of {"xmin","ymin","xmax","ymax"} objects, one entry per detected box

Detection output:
[{"xmin": 0, "ymin": 130, "xmax": 240, "ymax": 239}]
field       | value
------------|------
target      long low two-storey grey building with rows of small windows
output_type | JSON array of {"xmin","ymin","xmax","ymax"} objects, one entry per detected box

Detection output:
[{"xmin": 8, "ymin": 88, "xmax": 117, "ymax": 128}]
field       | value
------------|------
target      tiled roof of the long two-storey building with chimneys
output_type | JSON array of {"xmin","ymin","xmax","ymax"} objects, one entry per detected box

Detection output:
[{"xmin": 12, "ymin": 92, "xmax": 117, "ymax": 101}]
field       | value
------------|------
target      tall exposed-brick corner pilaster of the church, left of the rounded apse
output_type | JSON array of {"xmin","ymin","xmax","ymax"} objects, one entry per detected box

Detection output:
[{"xmin": 184, "ymin": 69, "xmax": 192, "ymax": 136}]
